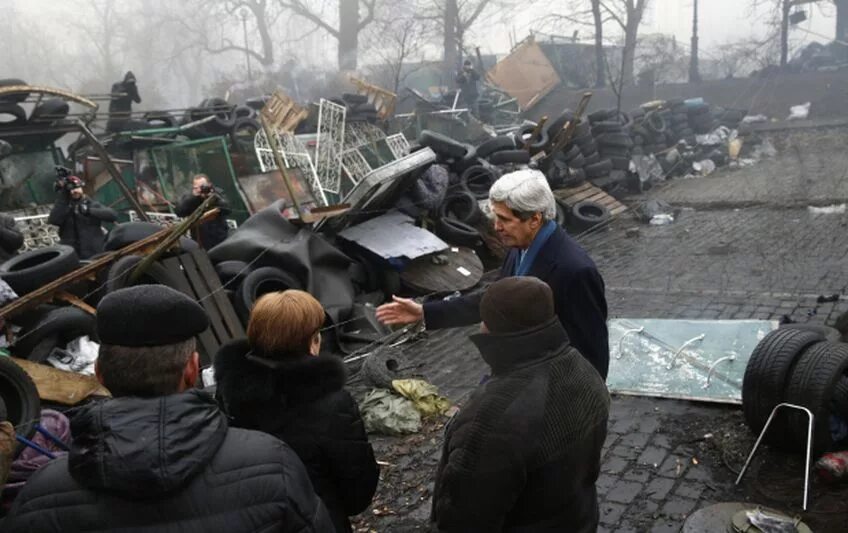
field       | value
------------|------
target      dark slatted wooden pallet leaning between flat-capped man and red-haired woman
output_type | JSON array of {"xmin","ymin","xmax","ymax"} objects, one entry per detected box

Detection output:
[{"xmin": 162, "ymin": 250, "xmax": 245, "ymax": 366}]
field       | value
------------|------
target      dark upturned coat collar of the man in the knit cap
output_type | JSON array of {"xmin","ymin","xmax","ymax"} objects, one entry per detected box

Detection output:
[{"xmin": 471, "ymin": 316, "xmax": 571, "ymax": 376}]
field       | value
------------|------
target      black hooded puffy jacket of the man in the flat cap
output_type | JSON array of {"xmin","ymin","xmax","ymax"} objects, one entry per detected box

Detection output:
[{"xmin": 0, "ymin": 390, "xmax": 333, "ymax": 533}]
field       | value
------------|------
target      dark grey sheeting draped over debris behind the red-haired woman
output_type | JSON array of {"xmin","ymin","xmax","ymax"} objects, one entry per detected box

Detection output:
[{"xmin": 209, "ymin": 200, "xmax": 354, "ymax": 323}]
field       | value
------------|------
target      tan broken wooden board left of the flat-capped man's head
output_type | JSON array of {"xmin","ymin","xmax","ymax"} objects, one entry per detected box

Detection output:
[{"xmin": 9, "ymin": 357, "xmax": 112, "ymax": 405}]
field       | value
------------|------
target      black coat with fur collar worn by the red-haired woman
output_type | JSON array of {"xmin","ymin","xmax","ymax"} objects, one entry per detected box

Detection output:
[{"xmin": 215, "ymin": 340, "xmax": 379, "ymax": 531}]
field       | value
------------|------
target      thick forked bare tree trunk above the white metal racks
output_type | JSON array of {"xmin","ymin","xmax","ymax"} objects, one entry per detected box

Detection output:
[{"xmin": 279, "ymin": 0, "xmax": 377, "ymax": 70}]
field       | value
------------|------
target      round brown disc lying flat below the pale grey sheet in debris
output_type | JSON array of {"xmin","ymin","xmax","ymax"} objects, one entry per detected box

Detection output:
[{"xmin": 400, "ymin": 247, "xmax": 483, "ymax": 294}]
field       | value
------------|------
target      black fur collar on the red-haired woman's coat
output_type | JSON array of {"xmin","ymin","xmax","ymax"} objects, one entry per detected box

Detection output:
[{"xmin": 215, "ymin": 339, "xmax": 347, "ymax": 407}]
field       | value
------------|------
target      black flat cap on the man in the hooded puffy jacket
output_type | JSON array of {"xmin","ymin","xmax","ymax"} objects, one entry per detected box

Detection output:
[{"xmin": 97, "ymin": 285, "xmax": 209, "ymax": 346}]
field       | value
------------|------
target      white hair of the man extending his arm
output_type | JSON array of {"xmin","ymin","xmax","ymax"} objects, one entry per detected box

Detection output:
[{"xmin": 489, "ymin": 168, "xmax": 556, "ymax": 221}]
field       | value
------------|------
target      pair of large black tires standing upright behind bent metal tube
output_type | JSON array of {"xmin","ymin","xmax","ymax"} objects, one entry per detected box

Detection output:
[{"xmin": 742, "ymin": 324, "xmax": 848, "ymax": 456}]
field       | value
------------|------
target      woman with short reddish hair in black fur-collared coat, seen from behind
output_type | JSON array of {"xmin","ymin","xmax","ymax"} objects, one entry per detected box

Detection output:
[{"xmin": 215, "ymin": 290, "xmax": 379, "ymax": 532}]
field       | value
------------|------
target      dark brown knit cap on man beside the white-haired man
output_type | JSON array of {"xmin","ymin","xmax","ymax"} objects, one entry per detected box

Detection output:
[{"xmin": 480, "ymin": 276, "xmax": 555, "ymax": 333}]
